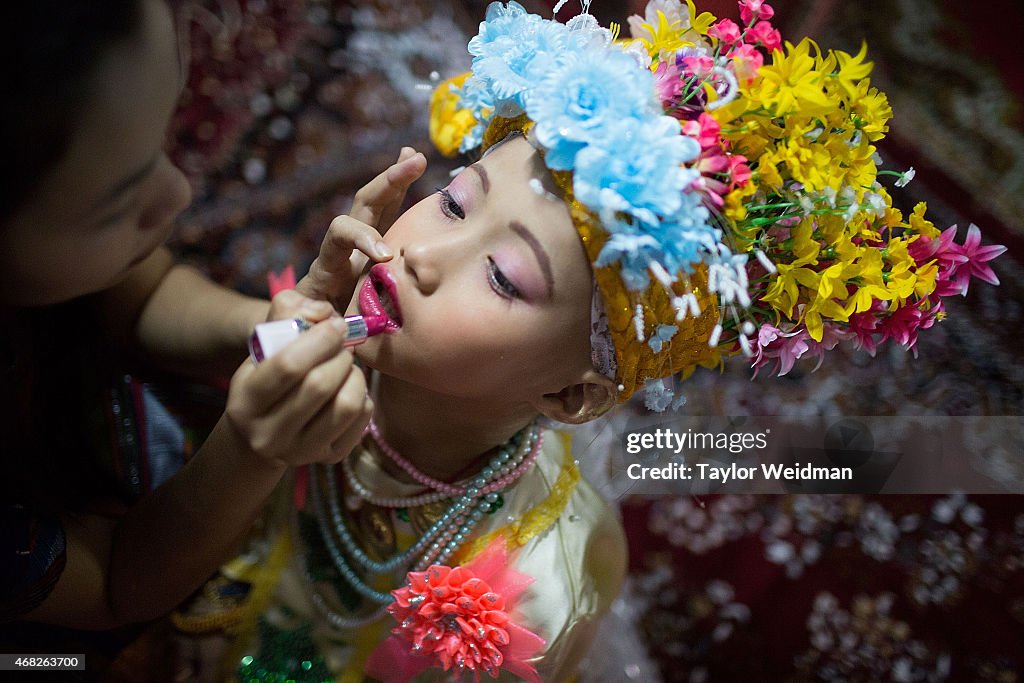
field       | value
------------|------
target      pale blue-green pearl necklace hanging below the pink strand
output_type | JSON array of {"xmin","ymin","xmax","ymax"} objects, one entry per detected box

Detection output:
[{"xmin": 309, "ymin": 425, "xmax": 543, "ymax": 607}]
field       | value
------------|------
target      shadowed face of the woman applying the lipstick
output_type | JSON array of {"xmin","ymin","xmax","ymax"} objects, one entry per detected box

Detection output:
[{"xmin": 0, "ymin": 0, "xmax": 190, "ymax": 305}]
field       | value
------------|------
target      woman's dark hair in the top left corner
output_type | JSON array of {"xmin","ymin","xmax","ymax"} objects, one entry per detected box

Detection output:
[{"xmin": 0, "ymin": 0, "xmax": 142, "ymax": 221}]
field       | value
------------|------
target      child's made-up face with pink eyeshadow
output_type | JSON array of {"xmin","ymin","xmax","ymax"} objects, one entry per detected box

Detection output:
[{"xmin": 356, "ymin": 137, "xmax": 593, "ymax": 404}]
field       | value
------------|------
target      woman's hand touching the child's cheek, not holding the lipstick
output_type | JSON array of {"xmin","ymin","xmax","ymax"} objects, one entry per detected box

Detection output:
[{"xmin": 296, "ymin": 147, "xmax": 427, "ymax": 311}]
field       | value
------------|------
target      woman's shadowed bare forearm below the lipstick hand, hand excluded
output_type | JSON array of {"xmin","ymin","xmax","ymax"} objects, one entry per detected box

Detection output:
[{"xmin": 26, "ymin": 425, "xmax": 284, "ymax": 630}]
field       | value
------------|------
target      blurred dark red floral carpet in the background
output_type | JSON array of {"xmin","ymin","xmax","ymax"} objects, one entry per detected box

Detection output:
[{"xmin": 163, "ymin": 0, "xmax": 1024, "ymax": 681}]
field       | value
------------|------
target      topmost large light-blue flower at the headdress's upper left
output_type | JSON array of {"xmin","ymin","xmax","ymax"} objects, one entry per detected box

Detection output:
[{"xmin": 469, "ymin": 2, "xmax": 584, "ymax": 117}]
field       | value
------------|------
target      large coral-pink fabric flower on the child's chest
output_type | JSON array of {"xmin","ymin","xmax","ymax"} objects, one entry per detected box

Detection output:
[{"xmin": 366, "ymin": 537, "xmax": 545, "ymax": 683}]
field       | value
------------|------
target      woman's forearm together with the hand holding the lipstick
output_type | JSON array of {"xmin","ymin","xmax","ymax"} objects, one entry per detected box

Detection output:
[{"xmin": 28, "ymin": 292, "xmax": 373, "ymax": 629}]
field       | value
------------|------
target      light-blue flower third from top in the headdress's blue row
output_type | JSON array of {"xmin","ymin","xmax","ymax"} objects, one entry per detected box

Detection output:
[{"xmin": 572, "ymin": 116, "xmax": 700, "ymax": 223}]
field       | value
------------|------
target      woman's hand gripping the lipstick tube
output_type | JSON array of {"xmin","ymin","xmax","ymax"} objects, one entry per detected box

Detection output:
[{"xmin": 224, "ymin": 290, "xmax": 373, "ymax": 469}]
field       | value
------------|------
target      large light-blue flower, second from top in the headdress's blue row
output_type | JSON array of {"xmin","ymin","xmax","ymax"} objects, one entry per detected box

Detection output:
[{"xmin": 526, "ymin": 45, "xmax": 659, "ymax": 170}]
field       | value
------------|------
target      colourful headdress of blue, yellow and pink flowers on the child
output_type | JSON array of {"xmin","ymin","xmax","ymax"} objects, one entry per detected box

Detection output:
[{"xmin": 430, "ymin": 0, "xmax": 1005, "ymax": 410}]
